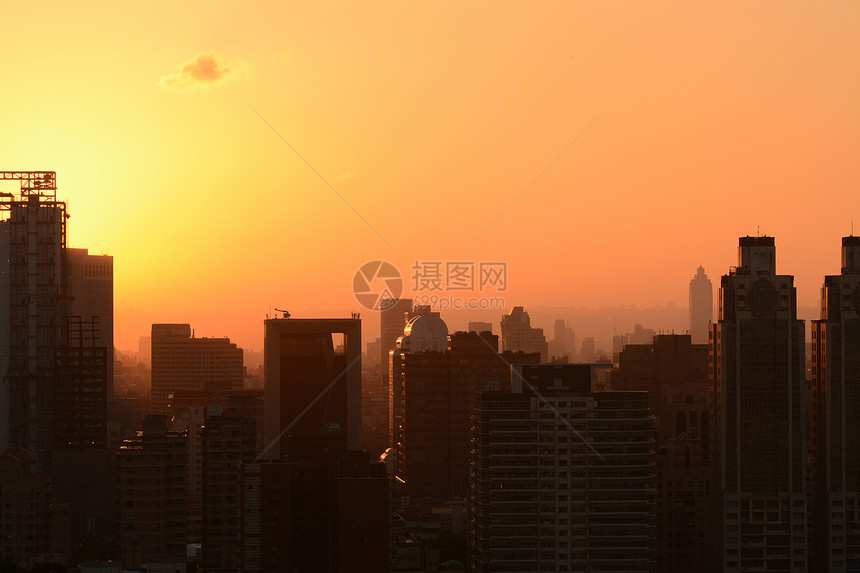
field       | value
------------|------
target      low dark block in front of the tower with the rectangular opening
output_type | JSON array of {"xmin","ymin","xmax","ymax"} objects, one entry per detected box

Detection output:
[{"xmin": 240, "ymin": 436, "xmax": 390, "ymax": 573}]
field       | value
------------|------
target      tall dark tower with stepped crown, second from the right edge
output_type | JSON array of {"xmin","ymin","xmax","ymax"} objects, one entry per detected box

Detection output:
[{"xmin": 711, "ymin": 237, "xmax": 809, "ymax": 571}]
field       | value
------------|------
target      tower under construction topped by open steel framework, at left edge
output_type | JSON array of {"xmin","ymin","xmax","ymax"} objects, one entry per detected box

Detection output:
[{"xmin": 0, "ymin": 171, "xmax": 113, "ymax": 470}]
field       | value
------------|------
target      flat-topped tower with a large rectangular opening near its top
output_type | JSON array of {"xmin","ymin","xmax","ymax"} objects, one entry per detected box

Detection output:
[{"xmin": 258, "ymin": 318, "xmax": 361, "ymax": 459}]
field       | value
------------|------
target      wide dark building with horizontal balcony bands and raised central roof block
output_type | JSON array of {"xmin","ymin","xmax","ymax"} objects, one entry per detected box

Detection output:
[{"xmin": 469, "ymin": 364, "xmax": 654, "ymax": 572}]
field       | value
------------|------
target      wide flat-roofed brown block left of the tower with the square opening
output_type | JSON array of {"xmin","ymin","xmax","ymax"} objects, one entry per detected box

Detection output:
[{"xmin": 152, "ymin": 324, "xmax": 245, "ymax": 415}]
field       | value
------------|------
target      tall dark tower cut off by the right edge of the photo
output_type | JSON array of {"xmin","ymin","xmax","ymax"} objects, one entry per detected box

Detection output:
[{"xmin": 810, "ymin": 236, "xmax": 860, "ymax": 571}]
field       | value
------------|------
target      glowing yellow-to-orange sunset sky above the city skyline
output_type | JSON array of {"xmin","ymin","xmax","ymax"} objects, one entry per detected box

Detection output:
[{"xmin": 0, "ymin": 0, "xmax": 860, "ymax": 349}]
